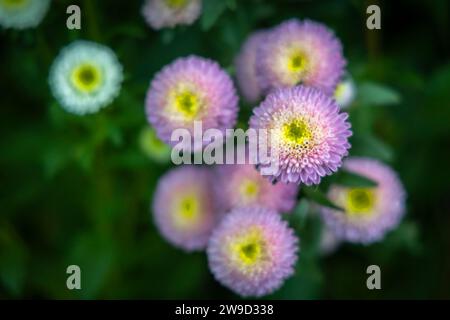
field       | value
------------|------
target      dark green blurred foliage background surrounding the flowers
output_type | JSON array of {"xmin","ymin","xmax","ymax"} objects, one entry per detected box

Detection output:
[{"xmin": 0, "ymin": 0, "xmax": 450, "ymax": 299}]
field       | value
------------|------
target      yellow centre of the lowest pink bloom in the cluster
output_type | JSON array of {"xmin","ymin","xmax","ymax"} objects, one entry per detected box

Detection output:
[{"xmin": 231, "ymin": 228, "xmax": 265, "ymax": 267}]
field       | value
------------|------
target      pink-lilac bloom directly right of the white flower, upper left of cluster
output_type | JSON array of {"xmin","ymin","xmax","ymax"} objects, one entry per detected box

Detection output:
[{"xmin": 146, "ymin": 56, "xmax": 238, "ymax": 149}]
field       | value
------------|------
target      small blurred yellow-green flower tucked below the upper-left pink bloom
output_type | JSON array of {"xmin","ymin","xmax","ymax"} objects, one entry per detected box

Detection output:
[{"xmin": 139, "ymin": 127, "xmax": 171, "ymax": 163}]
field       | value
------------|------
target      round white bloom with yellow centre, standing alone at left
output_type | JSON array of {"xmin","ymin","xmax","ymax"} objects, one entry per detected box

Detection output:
[{"xmin": 49, "ymin": 41, "xmax": 123, "ymax": 115}]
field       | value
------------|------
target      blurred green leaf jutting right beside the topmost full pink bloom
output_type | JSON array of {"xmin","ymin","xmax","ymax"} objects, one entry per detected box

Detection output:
[{"xmin": 358, "ymin": 82, "xmax": 401, "ymax": 106}]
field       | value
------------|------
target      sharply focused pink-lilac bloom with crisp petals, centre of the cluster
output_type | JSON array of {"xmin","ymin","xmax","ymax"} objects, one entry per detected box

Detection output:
[{"xmin": 250, "ymin": 86, "xmax": 352, "ymax": 185}]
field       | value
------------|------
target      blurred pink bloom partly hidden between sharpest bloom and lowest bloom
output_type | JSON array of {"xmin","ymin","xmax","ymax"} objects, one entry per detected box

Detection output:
[{"xmin": 215, "ymin": 163, "xmax": 298, "ymax": 213}]
